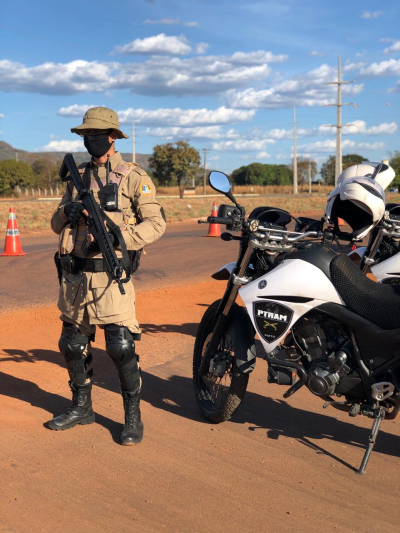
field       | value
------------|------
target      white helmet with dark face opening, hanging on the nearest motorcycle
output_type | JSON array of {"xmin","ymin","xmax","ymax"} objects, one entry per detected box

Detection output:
[{"xmin": 325, "ymin": 177, "xmax": 385, "ymax": 239}]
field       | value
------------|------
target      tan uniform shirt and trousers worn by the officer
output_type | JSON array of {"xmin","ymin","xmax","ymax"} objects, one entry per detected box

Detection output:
[{"xmin": 51, "ymin": 152, "xmax": 166, "ymax": 336}]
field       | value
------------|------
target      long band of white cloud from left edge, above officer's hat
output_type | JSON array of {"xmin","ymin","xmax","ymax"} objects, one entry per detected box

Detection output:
[{"xmin": 0, "ymin": 51, "xmax": 276, "ymax": 96}]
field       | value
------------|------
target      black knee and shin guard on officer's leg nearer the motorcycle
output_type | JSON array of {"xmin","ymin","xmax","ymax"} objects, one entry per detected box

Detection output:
[{"xmin": 104, "ymin": 324, "xmax": 140, "ymax": 392}]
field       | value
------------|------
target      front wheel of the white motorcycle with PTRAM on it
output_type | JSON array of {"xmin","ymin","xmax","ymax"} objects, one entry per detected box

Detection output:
[{"xmin": 193, "ymin": 300, "xmax": 249, "ymax": 424}]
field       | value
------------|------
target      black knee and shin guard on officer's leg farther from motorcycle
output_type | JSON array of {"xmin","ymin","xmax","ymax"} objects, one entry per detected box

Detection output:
[{"xmin": 58, "ymin": 322, "xmax": 93, "ymax": 385}]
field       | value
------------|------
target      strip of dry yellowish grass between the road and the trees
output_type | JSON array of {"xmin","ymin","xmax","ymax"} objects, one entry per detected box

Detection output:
[{"xmin": 4, "ymin": 194, "xmax": 400, "ymax": 235}]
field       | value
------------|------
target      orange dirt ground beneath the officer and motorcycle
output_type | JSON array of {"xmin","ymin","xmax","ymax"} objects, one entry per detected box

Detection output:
[{"xmin": 0, "ymin": 222, "xmax": 400, "ymax": 533}]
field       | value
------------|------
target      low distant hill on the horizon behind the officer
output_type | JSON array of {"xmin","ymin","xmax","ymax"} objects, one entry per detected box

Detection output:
[{"xmin": 0, "ymin": 141, "xmax": 150, "ymax": 170}]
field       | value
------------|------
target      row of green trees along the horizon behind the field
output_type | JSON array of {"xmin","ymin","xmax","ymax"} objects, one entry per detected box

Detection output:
[{"xmin": 0, "ymin": 141, "xmax": 400, "ymax": 197}]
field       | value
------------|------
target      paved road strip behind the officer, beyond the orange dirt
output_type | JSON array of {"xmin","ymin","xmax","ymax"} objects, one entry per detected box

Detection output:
[{"xmin": 0, "ymin": 222, "xmax": 238, "ymax": 311}]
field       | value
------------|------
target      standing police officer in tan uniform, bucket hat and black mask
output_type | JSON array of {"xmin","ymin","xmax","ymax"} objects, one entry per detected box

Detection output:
[{"xmin": 48, "ymin": 107, "xmax": 166, "ymax": 445}]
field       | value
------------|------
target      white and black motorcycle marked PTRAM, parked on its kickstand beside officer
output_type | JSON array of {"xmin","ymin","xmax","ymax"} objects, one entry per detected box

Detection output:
[{"xmin": 193, "ymin": 172, "xmax": 400, "ymax": 474}]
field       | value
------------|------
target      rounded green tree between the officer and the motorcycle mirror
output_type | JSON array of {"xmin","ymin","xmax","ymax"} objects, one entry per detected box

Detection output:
[{"xmin": 149, "ymin": 141, "xmax": 201, "ymax": 198}]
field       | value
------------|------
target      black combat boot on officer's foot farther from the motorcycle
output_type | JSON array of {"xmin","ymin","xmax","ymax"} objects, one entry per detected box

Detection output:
[{"xmin": 48, "ymin": 381, "xmax": 94, "ymax": 431}]
